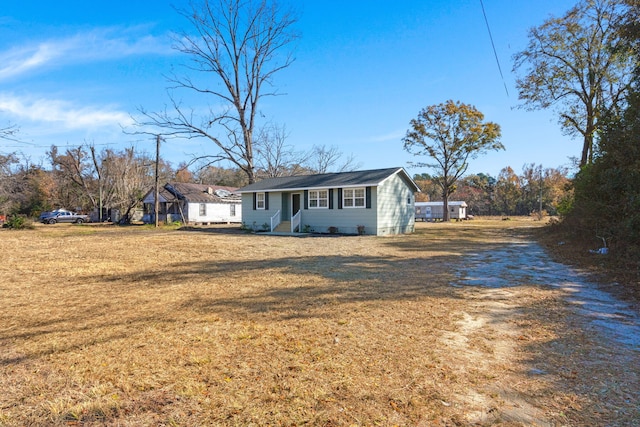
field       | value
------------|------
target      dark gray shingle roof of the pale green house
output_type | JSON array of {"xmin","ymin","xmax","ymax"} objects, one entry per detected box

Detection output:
[{"xmin": 237, "ymin": 167, "xmax": 419, "ymax": 193}]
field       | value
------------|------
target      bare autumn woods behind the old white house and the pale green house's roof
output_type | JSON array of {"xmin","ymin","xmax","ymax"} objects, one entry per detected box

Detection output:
[{"xmin": 0, "ymin": 139, "xmax": 358, "ymax": 219}]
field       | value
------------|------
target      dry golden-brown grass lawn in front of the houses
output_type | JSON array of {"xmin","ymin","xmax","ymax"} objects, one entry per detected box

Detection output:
[{"xmin": 0, "ymin": 220, "xmax": 639, "ymax": 426}]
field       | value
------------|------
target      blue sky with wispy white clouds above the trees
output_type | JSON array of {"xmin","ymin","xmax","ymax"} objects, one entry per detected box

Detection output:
[{"xmin": 0, "ymin": 0, "xmax": 581, "ymax": 176}]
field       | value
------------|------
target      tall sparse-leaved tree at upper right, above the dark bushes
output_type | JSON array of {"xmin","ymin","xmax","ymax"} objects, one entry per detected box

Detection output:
[{"xmin": 514, "ymin": 0, "xmax": 634, "ymax": 167}]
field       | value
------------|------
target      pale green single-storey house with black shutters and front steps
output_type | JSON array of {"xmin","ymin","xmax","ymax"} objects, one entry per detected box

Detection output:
[{"xmin": 238, "ymin": 168, "xmax": 420, "ymax": 236}]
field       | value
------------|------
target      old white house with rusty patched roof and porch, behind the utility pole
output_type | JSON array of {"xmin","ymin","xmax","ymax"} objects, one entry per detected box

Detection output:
[{"xmin": 142, "ymin": 182, "xmax": 242, "ymax": 224}]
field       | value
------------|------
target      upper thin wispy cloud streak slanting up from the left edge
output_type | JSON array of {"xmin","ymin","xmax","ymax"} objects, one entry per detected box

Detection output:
[{"xmin": 0, "ymin": 27, "xmax": 173, "ymax": 81}]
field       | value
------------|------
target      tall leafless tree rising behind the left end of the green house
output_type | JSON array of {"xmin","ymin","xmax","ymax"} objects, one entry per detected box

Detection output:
[{"xmin": 138, "ymin": 0, "xmax": 297, "ymax": 183}]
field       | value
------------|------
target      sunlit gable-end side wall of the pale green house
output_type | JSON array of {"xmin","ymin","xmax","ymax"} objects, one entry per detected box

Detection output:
[{"xmin": 376, "ymin": 174, "xmax": 415, "ymax": 236}]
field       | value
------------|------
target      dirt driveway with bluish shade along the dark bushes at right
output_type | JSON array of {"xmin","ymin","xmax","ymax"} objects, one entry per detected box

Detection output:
[{"xmin": 450, "ymin": 231, "xmax": 640, "ymax": 426}]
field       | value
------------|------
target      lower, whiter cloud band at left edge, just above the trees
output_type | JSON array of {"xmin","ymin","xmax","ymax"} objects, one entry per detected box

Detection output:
[{"xmin": 0, "ymin": 94, "xmax": 131, "ymax": 130}]
